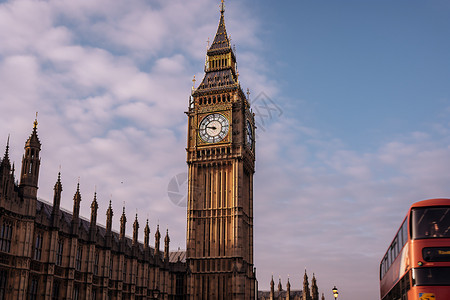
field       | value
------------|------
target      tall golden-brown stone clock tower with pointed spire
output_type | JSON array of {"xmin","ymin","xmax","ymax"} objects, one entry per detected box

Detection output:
[{"xmin": 186, "ymin": 0, "xmax": 256, "ymax": 300}]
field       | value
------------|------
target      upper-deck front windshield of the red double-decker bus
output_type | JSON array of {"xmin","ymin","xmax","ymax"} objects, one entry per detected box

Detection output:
[{"xmin": 411, "ymin": 207, "xmax": 450, "ymax": 239}]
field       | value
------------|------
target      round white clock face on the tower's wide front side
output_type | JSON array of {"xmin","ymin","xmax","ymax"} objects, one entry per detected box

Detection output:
[{"xmin": 199, "ymin": 114, "xmax": 230, "ymax": 143}]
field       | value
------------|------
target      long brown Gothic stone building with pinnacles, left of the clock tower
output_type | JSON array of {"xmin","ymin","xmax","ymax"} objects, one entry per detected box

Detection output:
[{"xmin": 0, "ymin": 121, "xmax": 186, "ymax": 300}]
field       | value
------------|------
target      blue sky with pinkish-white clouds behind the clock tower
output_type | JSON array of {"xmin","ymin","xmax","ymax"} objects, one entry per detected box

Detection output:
[{"xmin": 0, "ymin": 0, "xmax": 450, "ymax": 300}]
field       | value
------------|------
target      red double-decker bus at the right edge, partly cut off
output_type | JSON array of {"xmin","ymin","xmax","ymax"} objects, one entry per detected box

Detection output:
[{"xmin": 380, "ymin": 199, "xmax": 450, "ymax": 300}]
